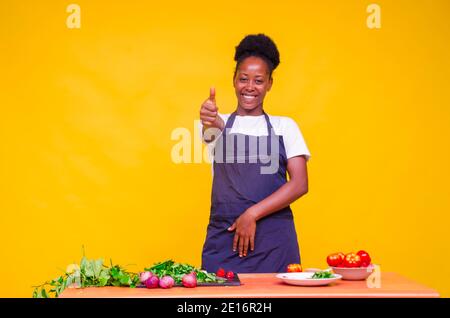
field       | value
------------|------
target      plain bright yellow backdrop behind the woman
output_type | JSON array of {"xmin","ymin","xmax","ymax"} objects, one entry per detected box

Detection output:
[{"xmin": 0, "ymin": 0, "xmax": 450, "ymax": 297}]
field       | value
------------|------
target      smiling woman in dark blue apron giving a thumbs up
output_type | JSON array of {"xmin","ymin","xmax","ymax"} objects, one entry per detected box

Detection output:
[{"xmin": 200, "ymin": 34, "xmax": 310, "ymax": 273}]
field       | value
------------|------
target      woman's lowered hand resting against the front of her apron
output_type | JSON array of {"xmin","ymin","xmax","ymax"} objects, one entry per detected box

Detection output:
[{"xmin": 228, "ymin": 209, "xmax": 256, "ymax": 257}]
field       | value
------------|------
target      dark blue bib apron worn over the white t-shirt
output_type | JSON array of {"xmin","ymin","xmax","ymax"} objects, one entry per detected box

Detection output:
[{"xmin": 202, "ymin": 112, "xmax": 300, "ymax": 273}]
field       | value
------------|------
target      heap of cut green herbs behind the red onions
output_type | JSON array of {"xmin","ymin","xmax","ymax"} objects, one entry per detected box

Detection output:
[{"xmin": 145, "ymin": 260, "xmax": 226, "ymax": 284}]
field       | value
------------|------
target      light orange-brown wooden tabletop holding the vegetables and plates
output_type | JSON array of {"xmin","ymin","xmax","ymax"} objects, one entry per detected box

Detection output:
[{"xmin": 60, "ymin": 272, "xmax": 439, "ymax": 298}]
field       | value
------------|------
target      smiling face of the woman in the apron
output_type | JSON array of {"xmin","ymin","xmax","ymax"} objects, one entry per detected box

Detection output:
[{"xmin": 234, "ymin": 56, "xmax": 272, "ymax": 113}]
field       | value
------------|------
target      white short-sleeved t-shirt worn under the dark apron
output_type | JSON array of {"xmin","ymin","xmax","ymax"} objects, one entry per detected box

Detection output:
[{"xmin": 200, "ymin": 113, "xmax": 311, "ymax": 169}]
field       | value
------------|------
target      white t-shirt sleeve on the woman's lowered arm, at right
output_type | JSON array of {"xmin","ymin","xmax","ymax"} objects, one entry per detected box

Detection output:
[{"xmin": 282, "ymin": 117, "xmax": 311, "ymax": 161}]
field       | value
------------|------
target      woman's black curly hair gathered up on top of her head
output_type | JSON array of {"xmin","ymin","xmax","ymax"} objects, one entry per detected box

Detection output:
[{"xmin": 233, "ymin": 33, "xmax": 280, "ymax": 78}]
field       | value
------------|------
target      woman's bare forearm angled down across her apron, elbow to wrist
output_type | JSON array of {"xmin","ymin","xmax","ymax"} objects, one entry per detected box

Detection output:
[{"xmin": 249, "ymin": 179, "xmax": 308, "ymax": 220}]
